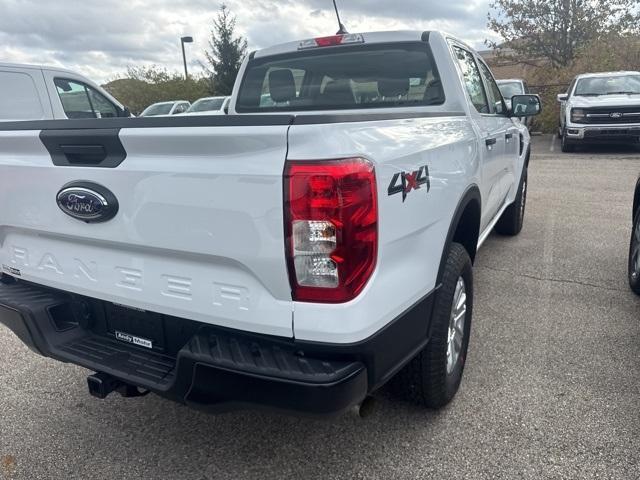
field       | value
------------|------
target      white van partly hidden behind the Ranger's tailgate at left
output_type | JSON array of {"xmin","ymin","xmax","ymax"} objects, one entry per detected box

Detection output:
[{"xmin": 0, "ymin": 63, "xmax": 131, "ymax": 122}]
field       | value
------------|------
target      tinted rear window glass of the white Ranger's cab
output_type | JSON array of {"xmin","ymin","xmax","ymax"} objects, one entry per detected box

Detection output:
[{"xmin": 236, "ymin": 42, "xmax": 444, "ymax": 113}]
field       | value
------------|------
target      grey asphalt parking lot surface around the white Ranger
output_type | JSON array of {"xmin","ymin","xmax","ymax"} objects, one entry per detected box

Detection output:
[{"xmin": 0, "ymin": 136, "xmax": 640, "ymax": 480}]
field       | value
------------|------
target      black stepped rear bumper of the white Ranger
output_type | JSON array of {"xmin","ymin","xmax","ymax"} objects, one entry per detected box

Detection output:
[{"xmin": 0, "ymin": 282, "xmax": 433, "ymax": 415}]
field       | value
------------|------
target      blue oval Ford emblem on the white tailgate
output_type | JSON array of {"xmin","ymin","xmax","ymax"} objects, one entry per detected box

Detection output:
[{"xmin": 56, "ymin": 182, "xmax": 118, "ymax": 223}]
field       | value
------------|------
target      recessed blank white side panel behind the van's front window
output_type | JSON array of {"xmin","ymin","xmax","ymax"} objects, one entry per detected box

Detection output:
[{"xmin": 0, "ymin": 72, "xmax": 44, "ymax": 120}]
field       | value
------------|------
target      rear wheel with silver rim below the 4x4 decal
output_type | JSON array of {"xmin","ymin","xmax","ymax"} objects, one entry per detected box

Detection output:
[{"xmin": 393, "ymin": 243, "xmax": 473, "ymax": 408}]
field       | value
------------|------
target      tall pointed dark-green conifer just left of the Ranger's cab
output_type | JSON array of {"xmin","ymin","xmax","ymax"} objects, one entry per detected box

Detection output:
[{"xmin": 205, "ymin": 3, "xmax": 247, "ymax": 95}]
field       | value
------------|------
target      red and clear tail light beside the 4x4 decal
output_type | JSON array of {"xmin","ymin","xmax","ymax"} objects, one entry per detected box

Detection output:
[{"xmin": 284, "ymin": 158, "xmax": 378, "ymax": 303}]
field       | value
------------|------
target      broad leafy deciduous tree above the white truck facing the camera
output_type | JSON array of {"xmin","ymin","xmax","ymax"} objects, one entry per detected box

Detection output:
[{"xmin": 487, "ymin": 0, "xmax": 640, "ymax": 67}]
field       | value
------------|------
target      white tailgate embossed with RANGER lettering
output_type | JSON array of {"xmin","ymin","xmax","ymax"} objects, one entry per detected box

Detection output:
[{"xmin": 0, "ymin": 119, "xmax": 292, "ymax": 337}]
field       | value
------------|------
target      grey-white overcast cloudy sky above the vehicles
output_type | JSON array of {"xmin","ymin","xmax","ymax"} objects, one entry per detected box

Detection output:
[{"xmin": 0, "ymin": 0, "xmax": 494, "ymax": 83}]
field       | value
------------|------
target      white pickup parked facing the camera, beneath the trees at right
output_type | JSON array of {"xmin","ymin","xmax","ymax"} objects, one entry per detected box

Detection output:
[{"xmin": 558, "ymin": 72, "xmax": 640, "ymax": 152}]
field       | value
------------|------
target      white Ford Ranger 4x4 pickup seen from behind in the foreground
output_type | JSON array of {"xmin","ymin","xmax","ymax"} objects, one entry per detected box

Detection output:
[{"xmin": 0, "ymin": 32, "xmax": 540, "ymax": 414}]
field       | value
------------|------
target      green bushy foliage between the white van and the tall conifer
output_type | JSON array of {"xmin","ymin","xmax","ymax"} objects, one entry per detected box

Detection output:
[{"xmin": 104, "ymin": 65, "xmax": 209, "ymax": 115}]
